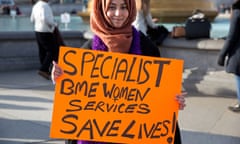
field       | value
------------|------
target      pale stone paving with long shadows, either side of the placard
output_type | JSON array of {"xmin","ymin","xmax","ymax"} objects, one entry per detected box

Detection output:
[{"xmin": 0, "ymin": 70, "xmax": 240, "ymax": 144}]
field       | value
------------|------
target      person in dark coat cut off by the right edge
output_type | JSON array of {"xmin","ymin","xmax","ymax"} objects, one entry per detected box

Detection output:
[{"xmin": 218, "ymin": 0, "xmax": 240, "ymax": 112}]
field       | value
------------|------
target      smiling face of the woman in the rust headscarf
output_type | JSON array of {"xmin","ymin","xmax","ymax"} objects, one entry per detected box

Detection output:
[{"xmin": 107, "ymin": 0, "xmax": 129, "ymax": 28}]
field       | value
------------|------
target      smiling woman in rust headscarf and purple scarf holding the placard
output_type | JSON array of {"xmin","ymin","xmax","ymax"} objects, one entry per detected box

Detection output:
[{"xmin": 52, "ymin": 0, "xmax": 186, "ymax": 144}]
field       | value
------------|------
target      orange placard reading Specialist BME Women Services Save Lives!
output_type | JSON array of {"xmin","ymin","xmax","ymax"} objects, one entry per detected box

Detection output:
[{"xmin": 50, "ymin": 47, "xmax": 183, "ymax": 144}]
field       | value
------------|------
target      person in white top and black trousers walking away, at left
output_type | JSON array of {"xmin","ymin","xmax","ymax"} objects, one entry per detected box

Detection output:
[{"xmin": 30, "ymin": 0, "xmax": 59, "ymax": 80}]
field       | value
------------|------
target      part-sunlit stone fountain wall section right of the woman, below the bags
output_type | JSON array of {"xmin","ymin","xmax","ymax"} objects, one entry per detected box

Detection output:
[{"xmin": 159, "ymin": 38, "xmax": 236, "ymax": 96}]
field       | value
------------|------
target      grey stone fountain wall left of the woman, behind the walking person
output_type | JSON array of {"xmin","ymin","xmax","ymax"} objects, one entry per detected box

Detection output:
[{"xmin": 0, "ymin": 31, "xmax": 84, "ymax": 72}]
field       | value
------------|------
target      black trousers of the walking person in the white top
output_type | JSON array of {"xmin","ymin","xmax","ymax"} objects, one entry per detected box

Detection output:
[{"xmin": 35, "ymin": 32, "xmax": 59, "ymax": 72}]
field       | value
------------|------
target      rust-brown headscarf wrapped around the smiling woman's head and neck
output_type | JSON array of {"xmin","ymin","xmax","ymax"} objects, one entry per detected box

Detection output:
[{"xmin": 90, "ymin": 0, "xmax": 136, "ymax": 53}]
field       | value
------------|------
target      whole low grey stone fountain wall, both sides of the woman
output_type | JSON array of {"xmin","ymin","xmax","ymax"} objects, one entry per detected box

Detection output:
[{"xmin": 0, "ymin": 31, "xmax": 235, "ymax": 95}]
